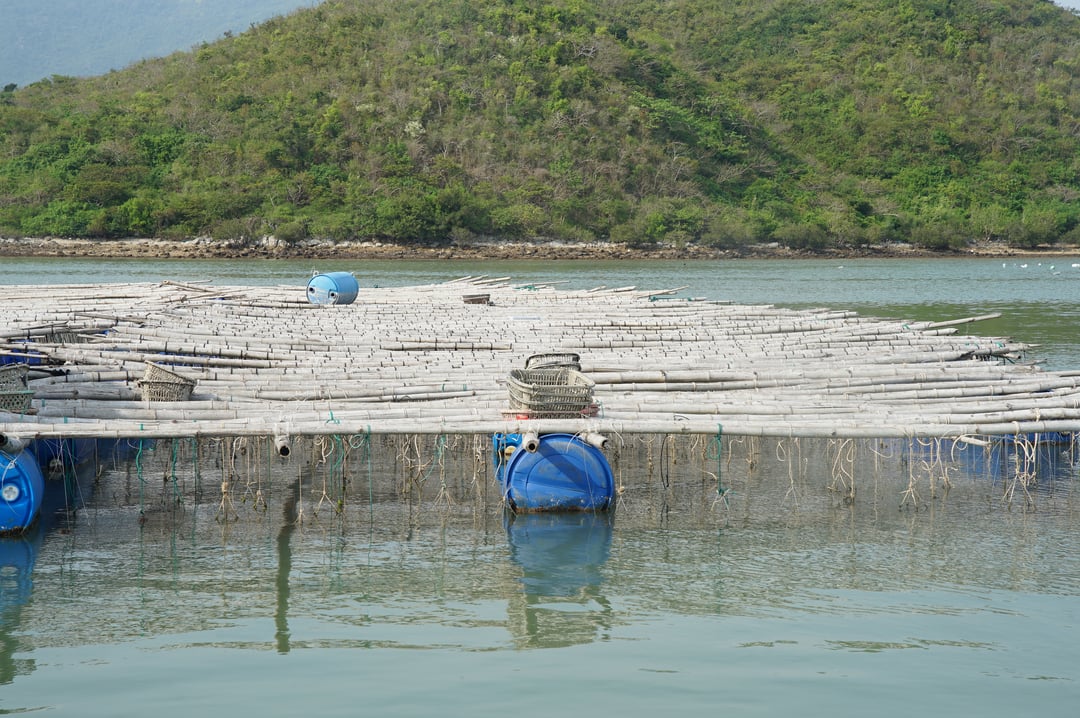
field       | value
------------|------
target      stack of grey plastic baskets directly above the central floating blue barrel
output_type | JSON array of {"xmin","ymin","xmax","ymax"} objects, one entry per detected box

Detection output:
[{"xmin": 507, "ymin": 354, "xmax": 595, "ymax": 419}]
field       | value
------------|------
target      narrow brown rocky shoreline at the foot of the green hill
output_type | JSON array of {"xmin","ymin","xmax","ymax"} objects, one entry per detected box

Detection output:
[{"xmin": 0, "ymin": 238, "xmax": 1080, "ymax": 260}]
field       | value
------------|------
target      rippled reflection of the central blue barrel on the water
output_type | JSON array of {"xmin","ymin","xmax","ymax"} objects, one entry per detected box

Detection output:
[{"xmin": 504, "ymin": 512, "xmax": 613, "ymax": 648}]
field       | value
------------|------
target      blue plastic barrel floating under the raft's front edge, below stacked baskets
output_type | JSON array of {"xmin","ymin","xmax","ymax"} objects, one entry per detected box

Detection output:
[{"xmin": 491, "ymin": 434, "xmax": 615, "ymax": 513}]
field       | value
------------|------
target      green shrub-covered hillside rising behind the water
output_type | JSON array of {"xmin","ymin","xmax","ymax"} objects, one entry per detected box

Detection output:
[{"xmin": 0, "ymin": 0, "xmax": 1080, "ymax": 248}]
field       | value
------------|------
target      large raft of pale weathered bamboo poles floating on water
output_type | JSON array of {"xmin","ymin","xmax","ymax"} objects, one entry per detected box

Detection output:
[{"xmin": 0, "ymin": 277, "xmax": 1080, "ymax": 448}]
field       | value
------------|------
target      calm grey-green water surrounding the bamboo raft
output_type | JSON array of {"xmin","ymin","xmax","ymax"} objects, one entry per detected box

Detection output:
[{"xmin": 0, "ymin": 254, "xmax": 1080, "ymax": 717}]
